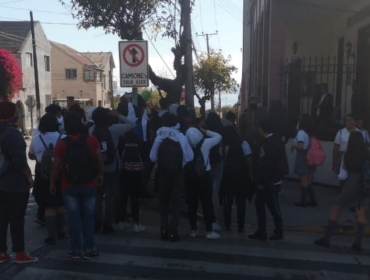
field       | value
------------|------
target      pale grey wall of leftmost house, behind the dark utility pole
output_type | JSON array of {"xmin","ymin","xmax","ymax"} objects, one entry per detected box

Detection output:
[{"xmin": 13, "ymin": 23, "xmax": 52, "ymax": 132}]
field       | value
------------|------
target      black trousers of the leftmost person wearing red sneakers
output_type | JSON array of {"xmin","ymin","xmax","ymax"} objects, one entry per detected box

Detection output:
[{"xmin": 0, "ymin": 191, "xmax": 29, "ymax": 253}]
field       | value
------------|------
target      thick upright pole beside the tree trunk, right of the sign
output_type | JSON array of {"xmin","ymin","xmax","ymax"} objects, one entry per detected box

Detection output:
[{"xmin": 181, "ymin": 0, "xmax": 194, "ymax": 110}]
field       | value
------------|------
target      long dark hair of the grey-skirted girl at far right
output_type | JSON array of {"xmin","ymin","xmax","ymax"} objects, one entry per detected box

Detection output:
[{"xmin": 344, "ymin": 131, "xmax": 369, "ymax": 172}]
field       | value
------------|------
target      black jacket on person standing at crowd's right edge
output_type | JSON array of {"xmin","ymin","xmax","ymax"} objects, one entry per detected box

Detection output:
[{"xmin": 257, "ymin": 135, "xmax": 284, "ymax": 187}]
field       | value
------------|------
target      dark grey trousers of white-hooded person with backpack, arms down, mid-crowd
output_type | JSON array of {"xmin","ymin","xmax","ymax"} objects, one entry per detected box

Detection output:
[{"xmin": 158, "ymin": 173, "xmax": 183, "ymax": 235}]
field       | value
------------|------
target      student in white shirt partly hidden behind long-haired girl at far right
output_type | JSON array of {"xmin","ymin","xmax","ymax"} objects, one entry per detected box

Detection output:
[{"xmin": 332, "ymin": 114, "xmax": 361, "ymax": 188}]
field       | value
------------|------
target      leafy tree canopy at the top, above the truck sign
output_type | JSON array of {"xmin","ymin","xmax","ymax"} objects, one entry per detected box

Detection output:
[{"xmin": 59, "ymin": 0, "xmax": 181, "ymax": 40}]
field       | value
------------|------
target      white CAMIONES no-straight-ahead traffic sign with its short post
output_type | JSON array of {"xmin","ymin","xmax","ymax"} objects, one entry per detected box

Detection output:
[{"xmin": 118, "ymin": 41, "xmax": 149, "ymax": 105}]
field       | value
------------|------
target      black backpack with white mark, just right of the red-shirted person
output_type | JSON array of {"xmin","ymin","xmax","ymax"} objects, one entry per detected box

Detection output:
[{"xmin": 93, "ymin": 127, "xmax": 116, "ymax": 165}]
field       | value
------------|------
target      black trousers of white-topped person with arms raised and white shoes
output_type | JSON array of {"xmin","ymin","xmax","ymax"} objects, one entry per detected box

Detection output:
[{"xmin": 186, "ymin": 171, "xmax": 214, "ymax": 231}]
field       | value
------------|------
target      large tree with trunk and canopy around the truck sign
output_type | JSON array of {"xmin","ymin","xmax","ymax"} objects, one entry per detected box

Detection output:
[{"xmin": 59, "ymin": 0, "xmax": 188, "ymax": 103}]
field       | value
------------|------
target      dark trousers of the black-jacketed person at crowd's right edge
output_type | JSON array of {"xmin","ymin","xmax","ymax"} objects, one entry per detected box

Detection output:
[{"xmin": 255, "ymin": 184, "xmax": 283, "ymax": 234}]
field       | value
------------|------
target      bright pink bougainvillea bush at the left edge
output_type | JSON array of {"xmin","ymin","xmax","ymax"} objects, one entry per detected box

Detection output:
[{"xmin": 0, "ymin": 49, "xmax": 22, "ymax": 101}]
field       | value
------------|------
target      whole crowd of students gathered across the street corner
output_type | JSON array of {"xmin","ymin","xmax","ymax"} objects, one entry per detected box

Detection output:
[{"xmin": 0, "ymin": 94, "xmax": 369, "ymax": 263}]
